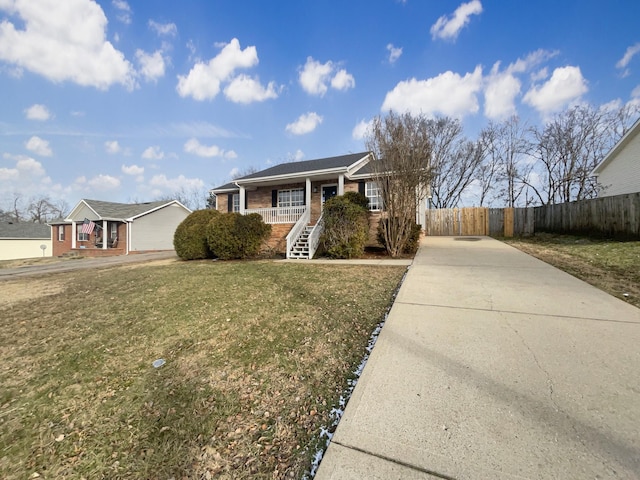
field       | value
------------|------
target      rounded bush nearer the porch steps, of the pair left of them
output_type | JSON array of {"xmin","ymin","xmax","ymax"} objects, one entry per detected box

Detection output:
[{"xmin": 207, "ymin": 212, "xmax": 271, "ymax": 260}]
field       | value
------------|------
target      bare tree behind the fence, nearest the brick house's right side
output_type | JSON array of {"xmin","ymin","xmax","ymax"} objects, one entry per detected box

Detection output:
[{"xmin": 425, "ymin": 117, "xmax": 483, "ymax": 208}]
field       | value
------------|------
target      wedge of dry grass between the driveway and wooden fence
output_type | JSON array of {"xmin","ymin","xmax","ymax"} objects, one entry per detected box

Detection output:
[{"xmin": 502, "ymin": 233, "xmax": 640, "ymax": 307}]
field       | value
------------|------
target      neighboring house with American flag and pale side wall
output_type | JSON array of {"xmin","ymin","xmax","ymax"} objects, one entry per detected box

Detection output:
[{"xmin": 51, "ymin": 200, "xmax": 191, "ymax": 257}]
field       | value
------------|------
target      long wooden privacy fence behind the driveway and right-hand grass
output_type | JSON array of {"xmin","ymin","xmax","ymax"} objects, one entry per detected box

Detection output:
[{"xmin": 424, "ymin": 193, "xmax": 640, "ymax": 237}]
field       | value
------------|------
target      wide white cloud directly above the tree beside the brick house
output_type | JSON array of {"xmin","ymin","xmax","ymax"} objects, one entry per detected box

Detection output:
[{"xmin": 381, "ymin": 66, "xmax": 482, "ymax": 118}]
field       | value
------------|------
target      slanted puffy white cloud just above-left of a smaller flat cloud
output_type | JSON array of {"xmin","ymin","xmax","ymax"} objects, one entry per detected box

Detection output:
[{"xmin": 176, "ymin": 38, "xmax": 258, "ymax": 100}]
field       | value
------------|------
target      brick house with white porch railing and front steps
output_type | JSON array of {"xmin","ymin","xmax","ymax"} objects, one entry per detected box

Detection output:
[{"xmin": 211, "ymin": 152, "xmax": 425, "ymax": 258}]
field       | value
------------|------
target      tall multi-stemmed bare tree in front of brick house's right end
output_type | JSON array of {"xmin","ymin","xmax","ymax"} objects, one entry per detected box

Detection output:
[{"xmin": 366, "ymin": 112, "xmax": 431, "ymax": 257}]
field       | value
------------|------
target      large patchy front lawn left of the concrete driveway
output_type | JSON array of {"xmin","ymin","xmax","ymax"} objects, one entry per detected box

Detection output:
[{"xmin": 0, "ymin": 261, "xmax": 405, "ymax": 479}]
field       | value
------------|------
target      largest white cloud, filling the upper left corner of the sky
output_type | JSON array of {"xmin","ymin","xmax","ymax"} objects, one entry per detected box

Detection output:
[{"xmin": 0, "ymin": 0, "xmax": 135, "ymax": 90}]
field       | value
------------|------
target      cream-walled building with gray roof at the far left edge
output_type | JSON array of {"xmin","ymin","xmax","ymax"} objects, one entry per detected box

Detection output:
[{"xmin": 0, "ymin": 222, "xmax": 52, "ymax": 260}]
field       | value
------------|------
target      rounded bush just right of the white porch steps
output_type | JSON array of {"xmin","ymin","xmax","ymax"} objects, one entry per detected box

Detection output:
[{"xmin": 321, "ymin": 196, "xmax": 369, "ymax": 258}]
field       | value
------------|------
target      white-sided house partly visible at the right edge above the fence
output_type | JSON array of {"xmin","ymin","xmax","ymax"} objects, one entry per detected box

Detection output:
[{"xmin": 591, "ymin": 120, "xmax": 640, "ymax": 197}]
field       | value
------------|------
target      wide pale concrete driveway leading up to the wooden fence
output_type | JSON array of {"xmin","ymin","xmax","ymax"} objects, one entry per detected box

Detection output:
[{"xmin": 316, "ymin": 237, "xmax": 640, "ymax": 480}]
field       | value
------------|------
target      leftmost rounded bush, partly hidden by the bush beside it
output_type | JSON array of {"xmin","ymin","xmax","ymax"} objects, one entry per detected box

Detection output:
[{"xmin": 173, "ymin": 209, "xmax": 220, "ymax": 260}]
